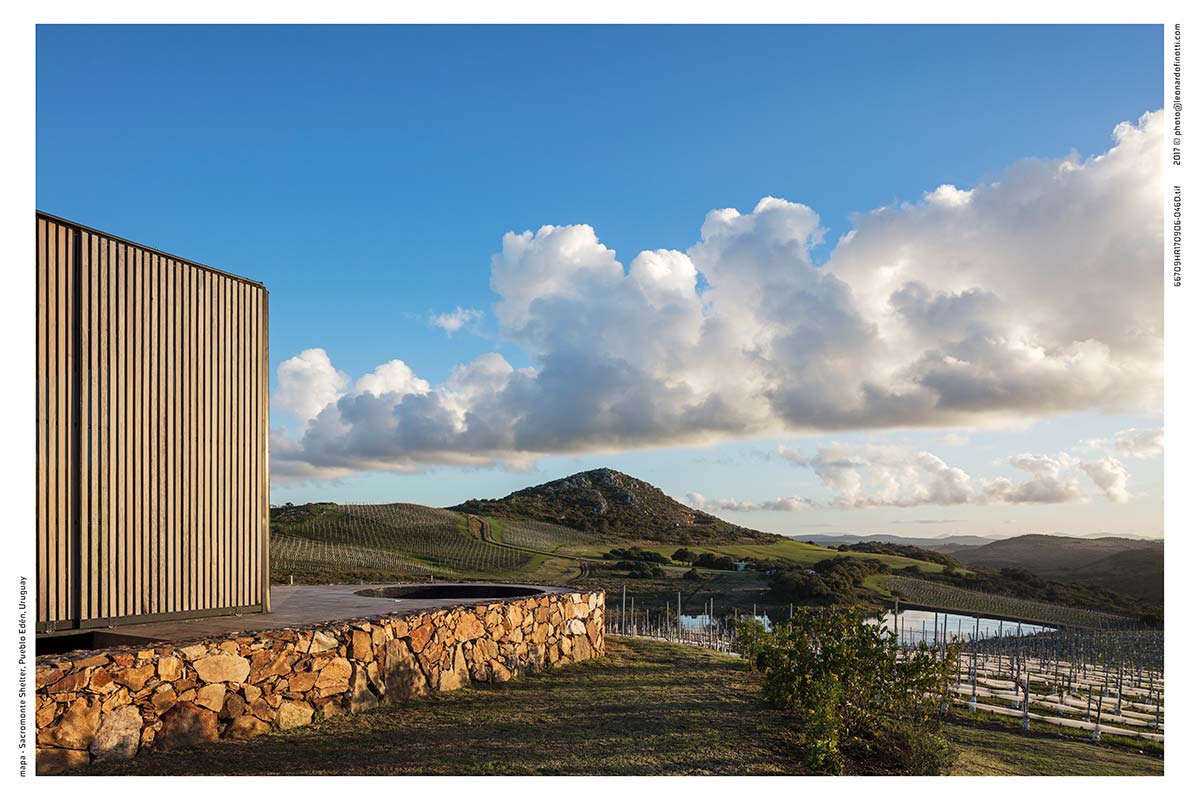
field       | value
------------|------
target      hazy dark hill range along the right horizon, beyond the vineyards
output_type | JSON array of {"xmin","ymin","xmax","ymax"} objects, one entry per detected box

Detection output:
[{"xmin": 793, "ymin": 534, "xmax": 1163, "ymax": 604}]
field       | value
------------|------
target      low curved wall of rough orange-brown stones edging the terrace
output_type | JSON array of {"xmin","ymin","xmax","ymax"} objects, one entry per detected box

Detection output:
[{"xmin": 37, "ymin": 591, "xmax": 605, "ymax": 774}]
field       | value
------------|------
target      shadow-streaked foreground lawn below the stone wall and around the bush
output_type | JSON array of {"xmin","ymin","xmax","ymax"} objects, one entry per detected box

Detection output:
[{"xmin": 77, "ymin": 638, "xmax": 1163, "ymax": 775}]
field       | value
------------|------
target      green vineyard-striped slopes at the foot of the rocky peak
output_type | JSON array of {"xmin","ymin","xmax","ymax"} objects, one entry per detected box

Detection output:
[{"xmin": 271, "ymin": 504, "xmax": 942, "ymax": 613}]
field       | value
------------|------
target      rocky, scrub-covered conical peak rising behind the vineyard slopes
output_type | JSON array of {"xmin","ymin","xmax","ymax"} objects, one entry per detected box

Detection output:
[{"xmin": 452, "ymin": 469, "xmax": 781, "ymax": 545}]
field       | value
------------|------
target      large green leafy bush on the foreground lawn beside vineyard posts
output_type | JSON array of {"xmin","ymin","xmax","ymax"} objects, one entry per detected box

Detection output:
[{"xmin": 736, "ymin": 608, "xmax": 956, "ymax": 775}]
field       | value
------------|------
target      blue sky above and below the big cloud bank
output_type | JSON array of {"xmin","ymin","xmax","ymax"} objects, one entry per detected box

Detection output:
[{"xmin": 37, "ymin": 25, "xmax": 1163, "ymax": 534}]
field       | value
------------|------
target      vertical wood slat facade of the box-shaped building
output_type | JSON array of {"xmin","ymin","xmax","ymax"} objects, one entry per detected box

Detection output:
[{"xmin": 36, "ymin": 212, "xmax": 270, "ymax": 632}]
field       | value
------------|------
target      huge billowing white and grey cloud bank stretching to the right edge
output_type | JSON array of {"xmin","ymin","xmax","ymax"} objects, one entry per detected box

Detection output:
[{"xmin": 272, "ymin": 113, "xmax": 1163, "ymax": 479}]
